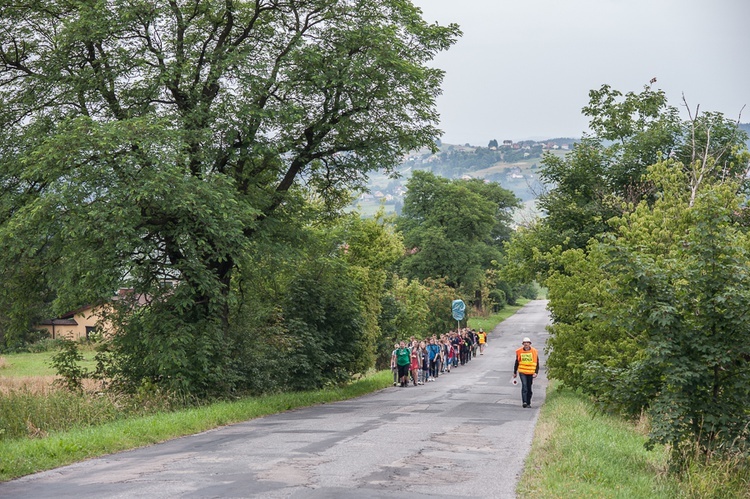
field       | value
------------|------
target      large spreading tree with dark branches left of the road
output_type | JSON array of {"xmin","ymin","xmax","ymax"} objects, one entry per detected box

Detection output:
[{"xmin": 0, "ymin": 0, "xmax": 459, "ymax": 388}]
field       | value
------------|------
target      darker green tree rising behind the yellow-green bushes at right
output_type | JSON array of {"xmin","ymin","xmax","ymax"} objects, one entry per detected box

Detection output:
[{"xmin": 507, "ymin": 85, "xmax": 747, "ymax": 282}]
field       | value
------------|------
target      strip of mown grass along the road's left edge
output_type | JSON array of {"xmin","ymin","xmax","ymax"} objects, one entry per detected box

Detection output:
[{"xmin": 0, "ymin": 371, "xmax": 393, "ymax": 481}]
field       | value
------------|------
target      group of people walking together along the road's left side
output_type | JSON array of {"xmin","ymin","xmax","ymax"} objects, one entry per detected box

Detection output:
[{"xmin": 391, "ymin": 328, "xmax": 487, "ymax": 387}]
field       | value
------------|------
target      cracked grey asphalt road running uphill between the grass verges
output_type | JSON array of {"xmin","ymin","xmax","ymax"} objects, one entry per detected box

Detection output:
[{"xmin": 0, "ymin": 300, "xmax": 549, "ymax": 499}]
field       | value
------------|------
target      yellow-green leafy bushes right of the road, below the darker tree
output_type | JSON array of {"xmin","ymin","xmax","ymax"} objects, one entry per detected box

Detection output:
[{"xmin": 548, "ymin": 162, "xmax": 750, "ymax": 459}]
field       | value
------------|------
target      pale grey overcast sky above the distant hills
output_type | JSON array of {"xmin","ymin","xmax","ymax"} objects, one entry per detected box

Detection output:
[{"xmin": 413, "ymin": 0, "xmax": 750, "ymax": 146}]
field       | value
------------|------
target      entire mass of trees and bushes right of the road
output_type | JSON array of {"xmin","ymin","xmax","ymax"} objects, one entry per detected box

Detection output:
[{"xmin": 512, "ymin": 85, "xmax": 750, "ymax": 462}]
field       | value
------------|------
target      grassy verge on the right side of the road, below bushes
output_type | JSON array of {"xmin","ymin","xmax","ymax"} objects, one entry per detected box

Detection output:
[{"xmin": 516, "ymin": 382, "xmax": 750, "ymax": 499}]
